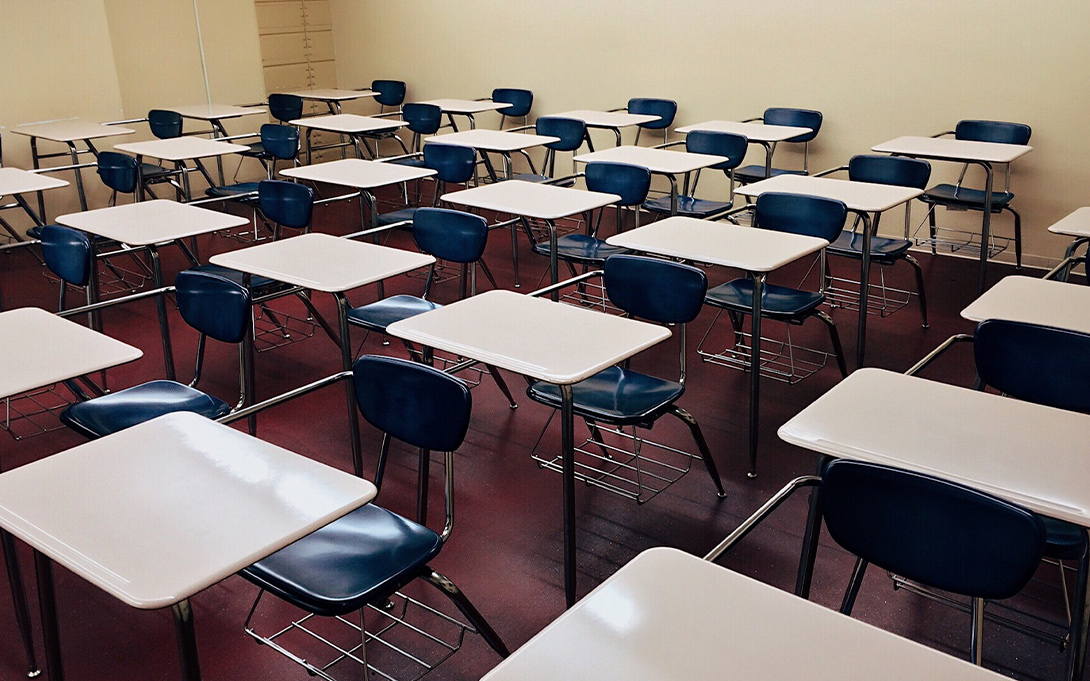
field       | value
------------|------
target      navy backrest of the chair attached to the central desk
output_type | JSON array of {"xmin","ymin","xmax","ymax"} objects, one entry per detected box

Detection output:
[{"xmin": 603, "ymin": 254, "xmax": 707, "ymax": 324}]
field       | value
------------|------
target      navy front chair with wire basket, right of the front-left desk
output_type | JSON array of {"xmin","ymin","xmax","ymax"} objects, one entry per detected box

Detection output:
[{"xmin": 240, "ymin": 356, "xmax": 509, "ymax": 679}]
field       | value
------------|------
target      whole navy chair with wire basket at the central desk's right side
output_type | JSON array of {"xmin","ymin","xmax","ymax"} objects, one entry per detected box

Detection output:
[{"xmin": 526, "ymin": 255, "xmax": 726, "ymax": 503}]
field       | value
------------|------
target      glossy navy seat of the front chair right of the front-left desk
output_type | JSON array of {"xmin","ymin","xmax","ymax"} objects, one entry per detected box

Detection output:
[{"xmin": 240, "ymin": 504, "xmax": 443, "ymax": 617}]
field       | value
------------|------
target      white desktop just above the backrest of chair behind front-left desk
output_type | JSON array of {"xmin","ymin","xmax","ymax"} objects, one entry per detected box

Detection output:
[{"xmin": 57, "ymin": 198, "xmax": 250, "ymax": 246}]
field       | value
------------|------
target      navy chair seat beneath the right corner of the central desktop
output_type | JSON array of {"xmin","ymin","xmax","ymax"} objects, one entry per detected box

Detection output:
[{"xmin": 526, "ymin": 366, "xmax": 685, "ymax": 428}]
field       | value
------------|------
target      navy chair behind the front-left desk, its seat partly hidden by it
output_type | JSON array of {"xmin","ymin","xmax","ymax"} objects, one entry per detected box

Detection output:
[{"xmin": 60, "ymin": 270, "xmax": 256, "ymax": 438}]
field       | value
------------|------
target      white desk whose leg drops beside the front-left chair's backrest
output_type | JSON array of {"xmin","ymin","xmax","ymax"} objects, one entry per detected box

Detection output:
[{"xmin": 208, "ymin": 230, "xmax": 435, "ymax": 476}]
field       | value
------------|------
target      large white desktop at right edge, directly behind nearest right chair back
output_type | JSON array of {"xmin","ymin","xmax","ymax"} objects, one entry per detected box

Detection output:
[{"xmin": 779, "ymin": 368, "xmax": 1090, "ymax": 526}]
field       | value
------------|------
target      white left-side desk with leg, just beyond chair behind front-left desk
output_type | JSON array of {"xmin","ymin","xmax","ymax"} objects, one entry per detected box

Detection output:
[{"xmin": 57, "ymin": 198, "xmax": 250, "ymax": 380}]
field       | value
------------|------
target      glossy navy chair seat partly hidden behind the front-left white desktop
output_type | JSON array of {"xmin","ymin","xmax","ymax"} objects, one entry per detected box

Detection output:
[{"xmin": 60, "ymin": 380, "xmax": 231, "ymax": 438}]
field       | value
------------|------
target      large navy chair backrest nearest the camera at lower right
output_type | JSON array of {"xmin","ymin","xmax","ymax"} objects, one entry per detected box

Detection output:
[{"xmin": 821, "ymin": 460, "xmax": 1045, "ymax": 598}]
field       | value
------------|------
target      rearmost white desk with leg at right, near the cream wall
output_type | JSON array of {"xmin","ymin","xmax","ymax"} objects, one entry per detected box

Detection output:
[{"xmin": 871, "ymin": 136, "xmax": 1033, "ymax": 293}]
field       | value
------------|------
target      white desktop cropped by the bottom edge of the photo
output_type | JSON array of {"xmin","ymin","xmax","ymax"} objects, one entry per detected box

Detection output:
[{"xmin": 482, "ymin": 547, "xmax": 1005, "ymax": 681}]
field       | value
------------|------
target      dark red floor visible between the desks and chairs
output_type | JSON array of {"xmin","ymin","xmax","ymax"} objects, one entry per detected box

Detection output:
[{"xmin": 0, "ymin": 192, "xmax": 1064, "ymax": 681}]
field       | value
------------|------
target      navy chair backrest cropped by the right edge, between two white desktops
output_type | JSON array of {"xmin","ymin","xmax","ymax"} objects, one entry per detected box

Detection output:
[{"xmin": 972, "ymin": 319, "xmax": 1090, "ymax": 414}]
